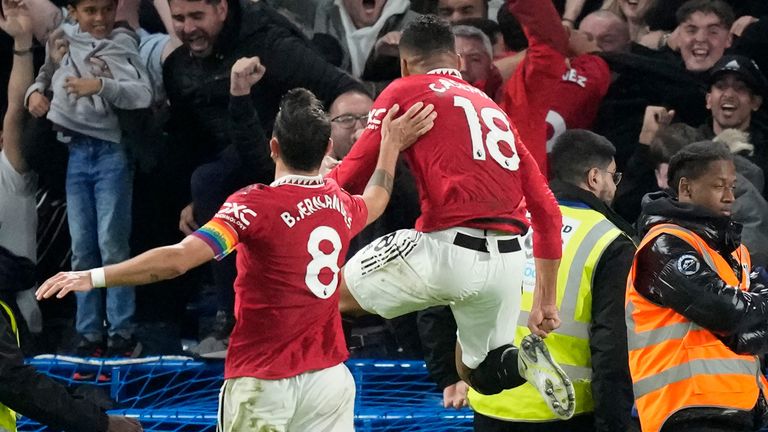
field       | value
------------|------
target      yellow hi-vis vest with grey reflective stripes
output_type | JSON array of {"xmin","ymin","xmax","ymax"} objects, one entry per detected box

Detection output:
[{"xmin": 469, "ymin": 204, "xmax": 624, "ymax": 422}]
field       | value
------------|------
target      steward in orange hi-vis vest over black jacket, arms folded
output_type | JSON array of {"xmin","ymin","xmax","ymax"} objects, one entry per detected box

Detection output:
[{"xmin": 626, "ymin": 141, "xmax": 768, "ymax": 432}]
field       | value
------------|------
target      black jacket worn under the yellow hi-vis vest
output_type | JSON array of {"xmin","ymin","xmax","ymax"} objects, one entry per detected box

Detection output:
[{"xmin": 550, "ymin": 180, "xmax": 635, "ymax": 432}]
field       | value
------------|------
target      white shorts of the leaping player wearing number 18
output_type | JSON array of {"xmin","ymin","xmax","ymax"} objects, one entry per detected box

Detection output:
[{"xmin": 344, "ymin": 228, "xmax": 525, "ymax": 369}]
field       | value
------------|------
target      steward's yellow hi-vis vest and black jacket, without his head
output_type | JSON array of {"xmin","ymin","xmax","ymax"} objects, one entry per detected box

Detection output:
[{"xmin": 469, "ymin": 176, "xmax": 635, "ymax": 432}]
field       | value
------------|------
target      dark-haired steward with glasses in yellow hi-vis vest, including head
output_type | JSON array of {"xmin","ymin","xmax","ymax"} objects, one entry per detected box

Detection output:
[{"xmin": 469, "ymin": 130, "xmax": 635, "ymax": 432}]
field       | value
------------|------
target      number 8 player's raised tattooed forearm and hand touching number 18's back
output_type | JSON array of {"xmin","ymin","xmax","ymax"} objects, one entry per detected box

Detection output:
[{"xmin": 363, "ymin": 102, "xmax": 437, "ymax": 225}]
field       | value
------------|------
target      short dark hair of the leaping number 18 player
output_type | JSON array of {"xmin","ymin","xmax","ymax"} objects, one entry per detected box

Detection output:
[{"xmin": 400, "ymin": 15, "xmax": 456, "ymax": 56}]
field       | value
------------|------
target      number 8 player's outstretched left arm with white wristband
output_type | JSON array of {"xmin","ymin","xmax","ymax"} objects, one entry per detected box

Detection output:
[{"xmin": 35, "ymin": 236, "xmax": 213, "ymax": 300}]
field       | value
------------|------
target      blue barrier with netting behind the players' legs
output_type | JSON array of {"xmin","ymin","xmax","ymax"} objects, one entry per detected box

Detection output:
[{"xmin": 18, "ymin": 356, "xmax": 472, "ymax": 432}]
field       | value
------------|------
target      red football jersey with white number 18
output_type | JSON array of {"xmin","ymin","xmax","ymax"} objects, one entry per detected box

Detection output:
[{"xmin": 329, "ymin": 69, "xmax": 562, "ymax": 258}]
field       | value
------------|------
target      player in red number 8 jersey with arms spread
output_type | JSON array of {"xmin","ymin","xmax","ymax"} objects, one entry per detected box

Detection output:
[{"xmin": 37, "ymin": 58, "xmax": 435, "ymax": 432}]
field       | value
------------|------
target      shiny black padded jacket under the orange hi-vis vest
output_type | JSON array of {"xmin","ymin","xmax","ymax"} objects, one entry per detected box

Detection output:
[{"xmin": 634, "ymin": 192, "xmax": 768, "ymax": 427}]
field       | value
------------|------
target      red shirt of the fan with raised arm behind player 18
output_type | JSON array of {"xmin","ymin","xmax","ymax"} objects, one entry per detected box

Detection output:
[{"xmin": 499, "ymin": 0, "xmax": 611, "ymax": 172}]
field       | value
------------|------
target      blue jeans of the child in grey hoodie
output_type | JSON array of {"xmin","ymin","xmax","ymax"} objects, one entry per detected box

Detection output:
[{"xmin": 66, "ymin": 136, "xmax": 136, "ymax": 341}]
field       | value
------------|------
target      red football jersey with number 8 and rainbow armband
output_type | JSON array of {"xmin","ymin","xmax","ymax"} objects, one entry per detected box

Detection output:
[{"xmin": 194, "ymin": 176, "xmax": 368, "ymax": 379}]
